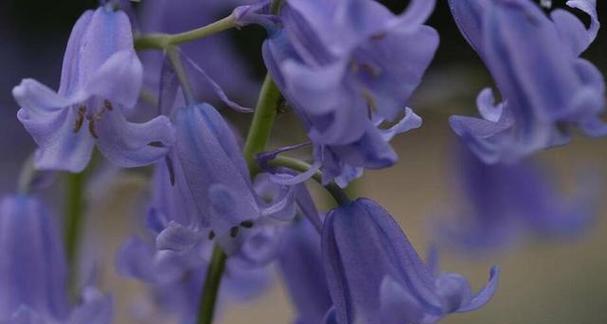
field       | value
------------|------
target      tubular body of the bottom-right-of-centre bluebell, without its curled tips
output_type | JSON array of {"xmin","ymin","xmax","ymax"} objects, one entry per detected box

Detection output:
[{"xmin": 322, "ymin": 199, "xmax": 442, "ymax": 323}]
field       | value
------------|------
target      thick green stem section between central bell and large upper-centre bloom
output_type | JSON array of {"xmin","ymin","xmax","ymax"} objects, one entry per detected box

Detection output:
[{"xmin": 244, "ymin": 74, "xmax": 281, "ymax": 175}]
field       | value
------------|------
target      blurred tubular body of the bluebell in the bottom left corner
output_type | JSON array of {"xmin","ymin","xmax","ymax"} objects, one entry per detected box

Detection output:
[{"xmin": 0, "ymin": 195, "xmax": 68, "ymax": 319}]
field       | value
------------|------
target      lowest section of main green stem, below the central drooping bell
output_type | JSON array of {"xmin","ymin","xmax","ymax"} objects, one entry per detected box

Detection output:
[{"xmin": 197, "ymin": 246, "xmax": 227, "ymax": 324}]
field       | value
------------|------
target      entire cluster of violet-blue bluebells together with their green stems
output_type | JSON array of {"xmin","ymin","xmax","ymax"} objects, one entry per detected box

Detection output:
[{"xmin": 0, "ymin": 0, "xmax": 607, "ymax": 324}]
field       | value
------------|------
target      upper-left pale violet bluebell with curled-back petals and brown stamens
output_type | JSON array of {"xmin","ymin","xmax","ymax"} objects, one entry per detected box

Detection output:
[{"xmin": 13, "ymin": 7, "xmax": 174, "ymax": 172}]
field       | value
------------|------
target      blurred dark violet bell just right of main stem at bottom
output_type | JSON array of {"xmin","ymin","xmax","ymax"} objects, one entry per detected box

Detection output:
[{"xmin": 278, "ymin": 219, "xmax": 333, "ymax": 324}]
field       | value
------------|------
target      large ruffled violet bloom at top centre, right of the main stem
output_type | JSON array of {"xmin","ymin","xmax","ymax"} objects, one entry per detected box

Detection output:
[{"xmin": 263, "ymin": 0, "xmax": 438, "ymax": 183}]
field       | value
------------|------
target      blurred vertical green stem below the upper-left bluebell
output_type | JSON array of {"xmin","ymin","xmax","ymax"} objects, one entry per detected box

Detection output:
[{"xmin": 64, "ymin": 172, "xmax": 86, "ymax": 297}]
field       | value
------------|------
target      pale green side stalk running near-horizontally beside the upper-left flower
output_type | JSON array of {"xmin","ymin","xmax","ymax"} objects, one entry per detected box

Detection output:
[{"xmin": 135, "ymin": 15, "xmax": 238, "ymax": 50}]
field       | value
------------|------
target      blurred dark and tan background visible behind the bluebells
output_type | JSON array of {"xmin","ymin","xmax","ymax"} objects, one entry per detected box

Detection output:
[{"xmin": 0, "ymin": 0, "xmax": 607, "ymax": 324}]
